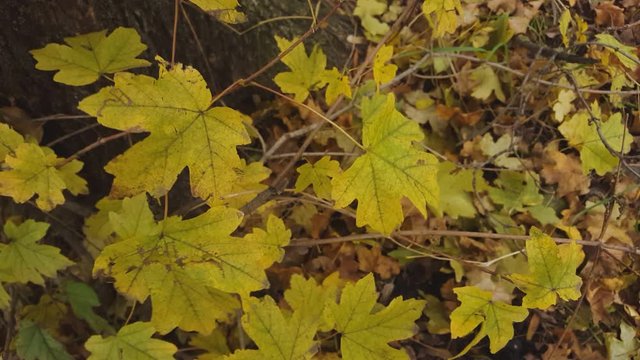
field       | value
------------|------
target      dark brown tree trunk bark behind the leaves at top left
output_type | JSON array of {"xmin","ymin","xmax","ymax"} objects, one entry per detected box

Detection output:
[{"xmin": 0, "ymin": 0, "xmax": 353, "ymax": 116}]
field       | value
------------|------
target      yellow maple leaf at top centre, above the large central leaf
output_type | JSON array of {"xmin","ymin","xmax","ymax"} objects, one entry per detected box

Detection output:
[{"xmin": 273, "ymin": 36, "xmax": 327, "ymax": 102}]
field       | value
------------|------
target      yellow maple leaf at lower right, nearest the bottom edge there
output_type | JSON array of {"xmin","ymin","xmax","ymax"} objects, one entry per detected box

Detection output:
[{"xmin": 450, "ymin": 286, "xmax": 529, "ymax": 357}]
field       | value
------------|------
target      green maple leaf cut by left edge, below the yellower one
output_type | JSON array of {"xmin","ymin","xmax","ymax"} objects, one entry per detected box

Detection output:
[{"xmin": 0, "ymin": 220, "xmax": 73, "ymax": 285}]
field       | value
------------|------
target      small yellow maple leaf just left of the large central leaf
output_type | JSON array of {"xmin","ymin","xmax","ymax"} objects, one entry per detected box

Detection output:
[{"xmin": 295, "ymin": 156, "xmax": 340, "ymax": 199}]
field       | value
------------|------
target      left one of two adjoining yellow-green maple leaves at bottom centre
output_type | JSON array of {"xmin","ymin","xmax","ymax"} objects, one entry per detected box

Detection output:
[{"xmin": 228, "ymin": 275, "xmax": 332, "ymax": 360}]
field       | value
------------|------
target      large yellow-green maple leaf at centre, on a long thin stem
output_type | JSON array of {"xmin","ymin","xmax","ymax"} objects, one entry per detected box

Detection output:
[{"xmin": 331, "ymin": 94, "xmax": 440, "ymax": 234}]
